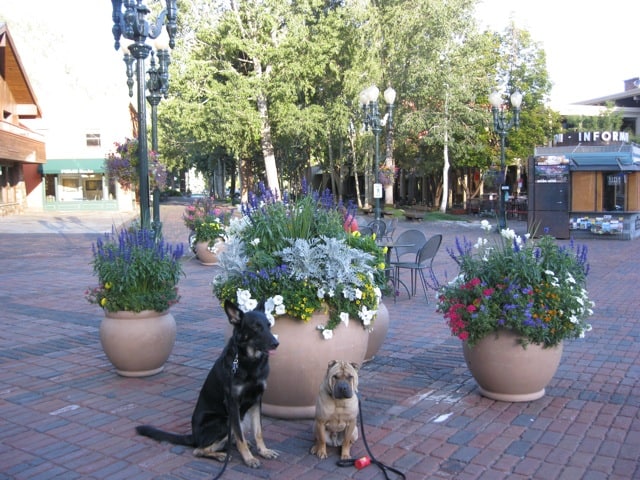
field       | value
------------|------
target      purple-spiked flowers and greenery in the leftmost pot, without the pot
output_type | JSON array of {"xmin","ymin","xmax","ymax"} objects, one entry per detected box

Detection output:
[{"xmin": 86, "ymin": 227, "xmax": 184, "ymax": 312}]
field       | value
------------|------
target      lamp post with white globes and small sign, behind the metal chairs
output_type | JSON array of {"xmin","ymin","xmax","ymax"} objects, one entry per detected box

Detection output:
[{"xmin": 360, "ymin": 85, "xmax": 396, "ymax": 220}]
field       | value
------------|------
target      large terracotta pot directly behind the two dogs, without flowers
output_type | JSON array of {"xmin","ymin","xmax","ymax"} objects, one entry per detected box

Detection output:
[{"xmin": 262, "ymin": 313, "xmax": 369, "ymax": 419}]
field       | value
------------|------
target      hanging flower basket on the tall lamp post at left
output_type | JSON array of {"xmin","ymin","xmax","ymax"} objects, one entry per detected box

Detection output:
[{"xmin": 105, "ymin": 138, "xmax": 167, "ymax": 190}]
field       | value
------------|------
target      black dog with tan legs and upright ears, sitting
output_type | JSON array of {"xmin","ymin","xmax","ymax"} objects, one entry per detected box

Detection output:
[{"xmin": 136, "ymin": 301, "xmax": 278, "ymax": 468}]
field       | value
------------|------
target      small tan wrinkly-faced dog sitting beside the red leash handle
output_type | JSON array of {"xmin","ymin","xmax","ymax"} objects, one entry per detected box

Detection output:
[{"xmin": 310, "ymin": 360, "xmax": 359, "ymax": 460}]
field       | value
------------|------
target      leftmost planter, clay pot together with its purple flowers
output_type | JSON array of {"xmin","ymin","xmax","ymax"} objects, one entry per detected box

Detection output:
[{"xmin": 86, "ymin": 227, "xmax": 184, "ymax": 377}]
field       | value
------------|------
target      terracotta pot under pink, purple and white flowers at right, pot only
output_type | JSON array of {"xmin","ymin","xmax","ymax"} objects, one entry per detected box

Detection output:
[{"xmin": 463, "ymin": 330, "xmax": 562, "ymax": 402}]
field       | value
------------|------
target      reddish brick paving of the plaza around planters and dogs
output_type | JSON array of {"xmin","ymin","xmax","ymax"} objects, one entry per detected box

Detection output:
[{"xmin": 0, "ymin": 202, "xmax": 640, "ymax": 480}]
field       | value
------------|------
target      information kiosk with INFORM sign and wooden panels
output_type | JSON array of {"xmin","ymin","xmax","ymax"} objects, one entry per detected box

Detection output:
[{"xmin": 528, "ymin": 132, "xmax": 640, "ymax": 240}]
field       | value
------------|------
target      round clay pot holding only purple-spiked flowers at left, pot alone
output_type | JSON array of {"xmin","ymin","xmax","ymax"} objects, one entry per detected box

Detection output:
[{"xmin": 100, "ymin": 310, "xmax": 176, "ymax": 377}]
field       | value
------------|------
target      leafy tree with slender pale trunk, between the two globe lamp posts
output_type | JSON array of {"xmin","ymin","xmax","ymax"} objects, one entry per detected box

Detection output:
[{"xmin": 386, "ymin": 0, "xmax": 491, "ymax": 211}]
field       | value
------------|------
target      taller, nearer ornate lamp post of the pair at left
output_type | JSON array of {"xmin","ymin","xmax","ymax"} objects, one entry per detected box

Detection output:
[{"xmin": 111, "ymin": 0, "xmax": 178, "ymax": 228}]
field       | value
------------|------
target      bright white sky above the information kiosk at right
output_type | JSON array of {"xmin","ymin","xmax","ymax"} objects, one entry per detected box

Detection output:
[{"xmin": 476, "ymin": 0, "xmax": 640, "ymax": 105}]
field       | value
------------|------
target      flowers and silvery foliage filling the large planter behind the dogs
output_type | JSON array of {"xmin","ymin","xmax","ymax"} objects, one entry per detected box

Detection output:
[{"xmin": 213, "ymin": 185, "xmax": 385, "ymax": 339}]
